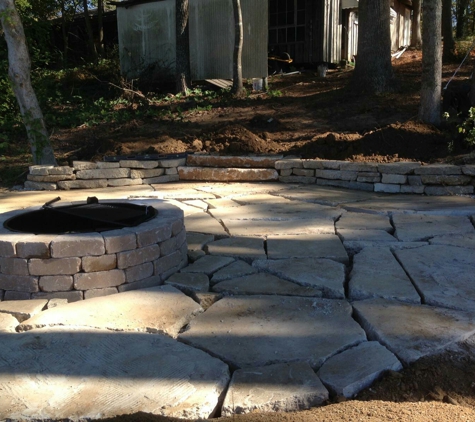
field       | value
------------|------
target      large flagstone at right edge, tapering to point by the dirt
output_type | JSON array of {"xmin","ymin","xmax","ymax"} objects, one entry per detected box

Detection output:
[{"xmin": 353, "ymin": 299, "xmax": 475, "ymax": 364}]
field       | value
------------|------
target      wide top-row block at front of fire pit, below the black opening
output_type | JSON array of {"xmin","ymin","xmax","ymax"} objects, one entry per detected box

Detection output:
[{"xmin": 50, "ymin": 233, "xmax": 105, "ymax": 258}]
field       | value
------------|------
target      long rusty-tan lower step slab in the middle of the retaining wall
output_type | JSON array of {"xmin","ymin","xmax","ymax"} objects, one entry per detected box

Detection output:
[{"xmin": 178, "ymin": 167, "xmax": 279, "ymax": 182}]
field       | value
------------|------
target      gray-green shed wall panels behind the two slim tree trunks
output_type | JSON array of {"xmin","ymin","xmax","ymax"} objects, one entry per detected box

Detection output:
[{"xmin": 117, "ymin": 0, "xmax": 268, "ymax": 80}]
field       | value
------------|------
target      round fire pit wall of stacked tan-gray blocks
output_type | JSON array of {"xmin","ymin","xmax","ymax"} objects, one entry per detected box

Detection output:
[{"xmin": 0, "ymin": 200, "xmax": 188, "ymax": 302}]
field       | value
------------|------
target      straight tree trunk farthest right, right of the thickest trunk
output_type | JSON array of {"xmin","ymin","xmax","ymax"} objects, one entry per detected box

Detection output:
[{"xmin": 419, "ymin": 0, "xmax": 442, "ymax": 126}]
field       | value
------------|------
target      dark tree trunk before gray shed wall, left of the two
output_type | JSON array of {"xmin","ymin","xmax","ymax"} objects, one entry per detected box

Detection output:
[{"xmin": 175, "ymin": 0, "xmax": 191, "ymax": 94}]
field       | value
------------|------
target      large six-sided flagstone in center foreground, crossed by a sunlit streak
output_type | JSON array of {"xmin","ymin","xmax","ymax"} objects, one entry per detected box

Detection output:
[{"xmin": 179, "ymin": 296, "xmax": 366, "ymax": 368}]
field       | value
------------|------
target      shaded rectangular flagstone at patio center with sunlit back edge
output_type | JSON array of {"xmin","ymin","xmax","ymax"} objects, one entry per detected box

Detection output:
[{"xmin": 267, "ymin": 234, "xmax": 349, "ymax": 264}]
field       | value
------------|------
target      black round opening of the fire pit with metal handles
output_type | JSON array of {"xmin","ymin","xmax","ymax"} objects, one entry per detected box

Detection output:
[{"xmin": 3, "ymin": 198, "xmax": 157, "ymax": 234}]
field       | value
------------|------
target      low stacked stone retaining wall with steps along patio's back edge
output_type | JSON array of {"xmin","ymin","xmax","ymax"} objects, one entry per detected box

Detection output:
[{"xmin": 25, "ymin": 154, "xmax": 475, "ymax": 195}]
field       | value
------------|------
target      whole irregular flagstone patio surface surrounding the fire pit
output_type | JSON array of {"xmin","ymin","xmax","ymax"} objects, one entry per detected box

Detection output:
[{"xmin": 0, "ymin": 183, "xmax": 475, "ymax": 420}]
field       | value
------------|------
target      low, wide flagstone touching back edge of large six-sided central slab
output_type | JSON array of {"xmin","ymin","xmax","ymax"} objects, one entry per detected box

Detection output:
[{"xmin": 212, "ymin": 273, "xmax": 322, "ymax": 297}]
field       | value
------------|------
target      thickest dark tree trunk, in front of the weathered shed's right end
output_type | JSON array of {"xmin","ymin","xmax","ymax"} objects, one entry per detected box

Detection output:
[{"xmin": 352, "ymin": 0, "xmax": 393, "ymax": 93}]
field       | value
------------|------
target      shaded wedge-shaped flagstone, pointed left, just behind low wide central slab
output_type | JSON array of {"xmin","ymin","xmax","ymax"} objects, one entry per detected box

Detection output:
[{"xmin": 252, "ymin": 258, "xmax": 345, "ymax": 299}]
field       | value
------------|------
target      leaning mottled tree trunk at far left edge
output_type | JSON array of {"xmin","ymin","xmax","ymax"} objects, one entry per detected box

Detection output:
[{"xmin": 0, "ymin": 0, "xmax": 56, "ymax": 165}]
